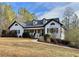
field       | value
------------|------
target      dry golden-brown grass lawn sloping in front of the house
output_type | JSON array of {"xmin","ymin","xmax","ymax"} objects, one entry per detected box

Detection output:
[{"xmin": 0, "ymin": 38, "xmax": 79, "ymax": 57}]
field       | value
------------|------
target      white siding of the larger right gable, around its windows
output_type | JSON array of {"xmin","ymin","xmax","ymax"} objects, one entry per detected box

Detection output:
[{"xmin": 45, "ymin": 21, "xmax": 64, "ymax": 39}]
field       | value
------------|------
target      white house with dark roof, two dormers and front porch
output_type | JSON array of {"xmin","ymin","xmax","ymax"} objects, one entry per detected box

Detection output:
[{"xmin": 9, "ymin": 18, "xmax": 65, "ymax": 40}]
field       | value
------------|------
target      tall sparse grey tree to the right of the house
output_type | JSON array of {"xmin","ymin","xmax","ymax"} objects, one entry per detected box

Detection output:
[{"xmin": 62, "ymin": 7, "xmax": 78, "ymax": 29}]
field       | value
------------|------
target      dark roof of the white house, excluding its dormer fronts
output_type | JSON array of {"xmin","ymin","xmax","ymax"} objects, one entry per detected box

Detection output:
[{"xmin": 8, "ymin": 18, "xmax": 64, "ymax": 29}]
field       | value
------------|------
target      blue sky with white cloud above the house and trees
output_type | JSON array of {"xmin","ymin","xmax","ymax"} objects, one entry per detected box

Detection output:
[{"xmin": 2, "ymin": 2, "xmax": 79, "ymax": 19}]
